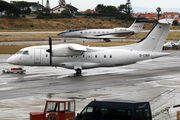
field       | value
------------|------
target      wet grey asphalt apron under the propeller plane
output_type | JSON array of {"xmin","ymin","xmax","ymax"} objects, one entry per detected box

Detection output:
[{"xmin": 0, "ymin": 50, "xmax": 180, "ymax": 120}]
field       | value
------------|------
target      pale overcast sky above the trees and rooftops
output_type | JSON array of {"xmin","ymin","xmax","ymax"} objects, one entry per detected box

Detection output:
[{"xmin": 4, "ymin": 0, "xmax": 180, "ymax": 13}]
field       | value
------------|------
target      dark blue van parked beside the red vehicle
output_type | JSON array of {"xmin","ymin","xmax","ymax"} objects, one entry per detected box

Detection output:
[{"xmin": 73, "ymin": 100, "xmax": 152, "ymax": 120}]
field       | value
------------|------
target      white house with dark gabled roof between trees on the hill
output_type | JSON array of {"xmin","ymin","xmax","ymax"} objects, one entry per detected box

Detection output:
[{"xmin": 50, "ymin": 0, "xmax": 78, "ymax": 13}]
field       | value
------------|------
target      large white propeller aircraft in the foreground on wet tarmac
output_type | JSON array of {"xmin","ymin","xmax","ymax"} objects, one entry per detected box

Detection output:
[{"xmin": 6, "ymin": 19, "xmax": 173, "ymax": 74}]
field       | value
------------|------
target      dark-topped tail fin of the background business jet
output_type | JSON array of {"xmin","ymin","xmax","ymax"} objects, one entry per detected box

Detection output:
[{"xmin": 129, "ymin": 18, "xmax": 149, "ymax": 34}]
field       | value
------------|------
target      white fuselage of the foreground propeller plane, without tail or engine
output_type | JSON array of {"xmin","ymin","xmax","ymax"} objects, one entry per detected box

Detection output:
[{"xmin": 7, "ymin": 46, "xmax": 168, "ymax": 69}]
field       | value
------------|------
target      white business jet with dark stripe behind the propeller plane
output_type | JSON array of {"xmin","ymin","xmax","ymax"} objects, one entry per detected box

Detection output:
[{"xmin": 58, "ymin": 18, "xmax": 149, "ymax": 42}]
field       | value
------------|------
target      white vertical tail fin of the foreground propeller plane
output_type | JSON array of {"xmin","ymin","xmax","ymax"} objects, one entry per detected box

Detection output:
[{"xmin": 135, "ymin": 19, "xmax": 173, "ymax": 52}]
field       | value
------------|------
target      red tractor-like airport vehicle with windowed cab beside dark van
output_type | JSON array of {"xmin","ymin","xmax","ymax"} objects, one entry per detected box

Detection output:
[{"xmin": 30, "ymin": 100, "xmax": 75, "ymax": 120}]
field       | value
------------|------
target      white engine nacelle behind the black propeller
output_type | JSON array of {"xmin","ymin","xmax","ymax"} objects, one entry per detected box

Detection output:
[{"xmin": 52, "ymin": 46, "xmax": 83, "ymax": 57}]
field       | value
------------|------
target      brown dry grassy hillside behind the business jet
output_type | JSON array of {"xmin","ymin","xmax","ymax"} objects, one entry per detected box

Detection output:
[{"xmin": 0, "ymin": 18, "xmax": 158, "ymax": 31}]
